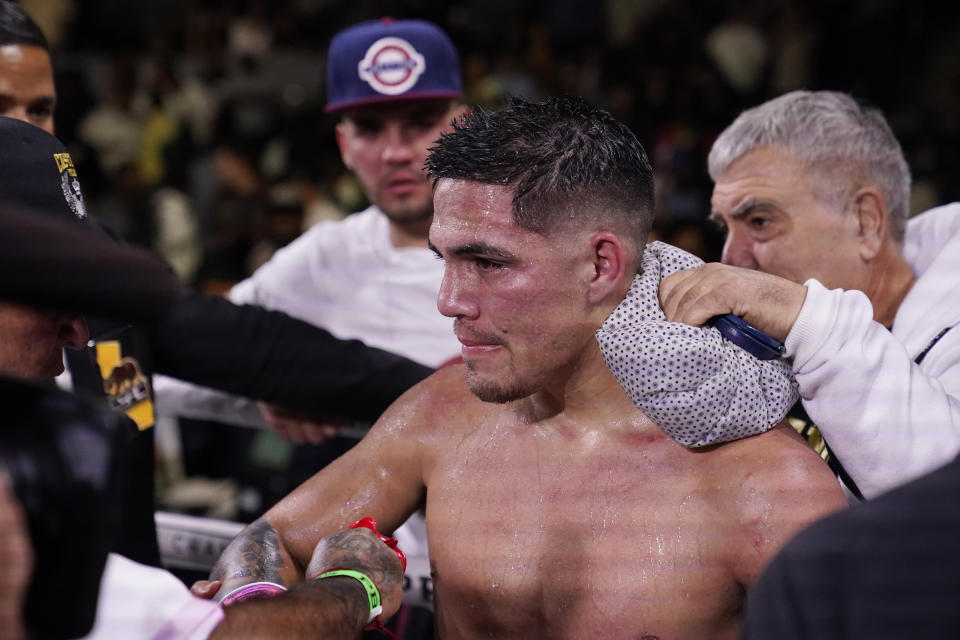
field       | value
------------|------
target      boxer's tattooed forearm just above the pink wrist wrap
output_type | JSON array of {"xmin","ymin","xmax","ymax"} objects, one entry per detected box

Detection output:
[{"xmin": 210, "ymin": 518, "xmax": 284, "ymax": 584}]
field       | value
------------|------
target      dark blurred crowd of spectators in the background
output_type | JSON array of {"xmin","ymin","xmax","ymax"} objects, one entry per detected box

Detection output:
[{"xmin": 31, "ymin": 0, "xmax": 960, "ymax": 282}]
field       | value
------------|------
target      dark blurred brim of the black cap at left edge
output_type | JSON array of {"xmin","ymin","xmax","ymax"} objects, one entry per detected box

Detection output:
[{"xmin": 0, "ymin": 204, "xmax": 180, "ymax": 322}]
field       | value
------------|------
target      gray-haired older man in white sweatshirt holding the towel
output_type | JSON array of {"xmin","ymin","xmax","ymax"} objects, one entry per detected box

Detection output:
[{"xmin": 660, "ymin": 91, "xmax": 960, "ymax": 498}]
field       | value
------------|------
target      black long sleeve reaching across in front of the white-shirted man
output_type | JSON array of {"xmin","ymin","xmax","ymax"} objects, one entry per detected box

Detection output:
[{"xmin": 152, "ymin": 292, "xmax": 433, "ymax": 421}]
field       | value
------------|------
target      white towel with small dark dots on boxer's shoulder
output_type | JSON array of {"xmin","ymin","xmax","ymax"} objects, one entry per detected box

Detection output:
[{"xmin": 596, "ymin": 242, "xmax": 799, "ymax": 447}]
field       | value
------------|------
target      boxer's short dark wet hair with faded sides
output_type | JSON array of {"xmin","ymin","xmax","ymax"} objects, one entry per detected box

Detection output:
[{"xmin": 426, "ymin": 97, "xmax": 653, "ymax": 247}]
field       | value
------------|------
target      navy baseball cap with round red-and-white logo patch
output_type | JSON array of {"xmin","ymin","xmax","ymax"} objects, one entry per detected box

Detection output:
[{"xmin": 326, "ymin": 18, "xmax": 463, "ymax": 112}]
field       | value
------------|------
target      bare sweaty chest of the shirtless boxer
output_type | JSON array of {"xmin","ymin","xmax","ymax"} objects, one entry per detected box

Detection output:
[{"xmin": 427, "ymin": 430, "xmax": 736, "ymax": 638}]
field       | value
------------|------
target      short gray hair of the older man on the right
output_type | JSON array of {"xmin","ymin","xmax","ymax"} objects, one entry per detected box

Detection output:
[{"xmin": 707, "ymin": 91, "xmax": 910, "ymax": 242}]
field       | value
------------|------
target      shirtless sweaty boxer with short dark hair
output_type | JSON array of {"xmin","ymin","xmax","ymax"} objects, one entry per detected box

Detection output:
[{"xmin": 194, "ymin": 98, "xmax": 844, "ymax": 639}]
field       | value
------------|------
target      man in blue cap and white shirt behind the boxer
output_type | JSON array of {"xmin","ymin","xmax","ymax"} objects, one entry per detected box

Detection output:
[{"xmin": 155, "ymin": 19, "xmax": 466, "ymax": 443}]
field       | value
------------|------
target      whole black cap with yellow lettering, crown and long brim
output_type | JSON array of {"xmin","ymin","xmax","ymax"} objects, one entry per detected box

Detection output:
[{"xmin": 0, "ymin": 117, "xmax": 179, "ymax": 321}]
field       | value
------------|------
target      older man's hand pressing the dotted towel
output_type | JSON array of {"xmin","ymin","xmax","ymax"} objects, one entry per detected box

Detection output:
[{"xmin": 659, "ymin": 263, "xmax": 807, "ymax": 342}]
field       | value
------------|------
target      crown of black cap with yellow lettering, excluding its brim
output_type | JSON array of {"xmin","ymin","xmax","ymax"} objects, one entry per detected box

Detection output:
[{"xmin": 0, "ymin": 117, "xmax": 87, "ymax": 220}]
